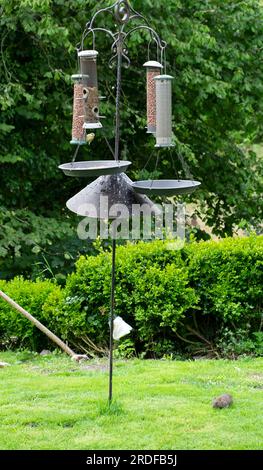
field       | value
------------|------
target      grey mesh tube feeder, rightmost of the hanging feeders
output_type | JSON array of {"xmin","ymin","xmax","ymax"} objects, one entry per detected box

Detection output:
[{"xmin": 154, "ymin": 75, "xmax": 174, "ymax": 147}]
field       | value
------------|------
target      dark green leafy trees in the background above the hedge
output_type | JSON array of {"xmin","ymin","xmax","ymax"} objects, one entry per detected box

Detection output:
[{"xmin": 0, "ymin": 0, "xmax": 263, "ymax": 281}]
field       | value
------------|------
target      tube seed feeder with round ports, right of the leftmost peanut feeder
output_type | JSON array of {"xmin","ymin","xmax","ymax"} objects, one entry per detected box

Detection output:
[{"xmin": 78, "ymin": 50, "xmax": 102, "ymax": 129}]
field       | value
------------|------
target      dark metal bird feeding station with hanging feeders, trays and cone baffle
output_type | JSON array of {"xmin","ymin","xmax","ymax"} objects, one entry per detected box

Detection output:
[{"xmin": 59, "ymin": 0, "xmax": 199, "ymax": 404}]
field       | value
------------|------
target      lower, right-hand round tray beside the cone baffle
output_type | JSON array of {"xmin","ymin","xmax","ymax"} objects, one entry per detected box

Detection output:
[{"xmin": 132, "ymin": 180, "xmax": 201, "ymax": 196}]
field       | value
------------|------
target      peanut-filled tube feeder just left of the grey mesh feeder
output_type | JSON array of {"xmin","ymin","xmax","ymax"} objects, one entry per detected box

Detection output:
[{"xmin": 143, "ymin": 60, "xmax": 163, "ymax": 134}]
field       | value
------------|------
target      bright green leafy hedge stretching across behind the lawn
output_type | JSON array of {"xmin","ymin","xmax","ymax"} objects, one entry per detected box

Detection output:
[{"xmin": 0, "ymin": 236, "xmax": 263, "ymax": 357}]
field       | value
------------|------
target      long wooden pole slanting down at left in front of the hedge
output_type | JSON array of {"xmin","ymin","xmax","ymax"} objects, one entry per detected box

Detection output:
[{"xmin": 0, "ymin": 290, "xmax": 87, "ymax": 362}]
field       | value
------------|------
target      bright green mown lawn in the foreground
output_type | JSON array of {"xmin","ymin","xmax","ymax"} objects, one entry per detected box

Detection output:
[{"xmin": 0, "ymin": 353, "xmax": 263, "ymax": 450}]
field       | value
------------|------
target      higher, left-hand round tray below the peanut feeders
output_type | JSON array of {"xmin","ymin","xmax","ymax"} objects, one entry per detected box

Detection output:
[{"xmin": 59, "ymin": 160, "xmax": 131, "ymax": 178}]
